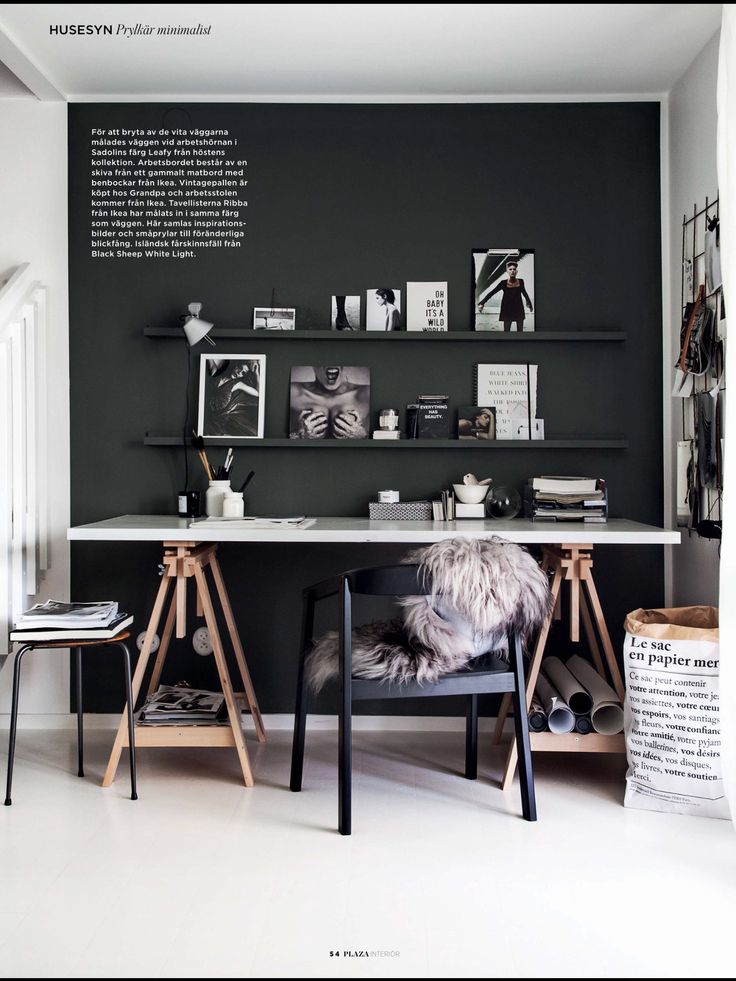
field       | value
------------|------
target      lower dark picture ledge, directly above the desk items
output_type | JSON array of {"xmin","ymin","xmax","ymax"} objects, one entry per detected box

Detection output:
[{"xmin": 143, "ymin": 434, "xmax": 629, "ymax": 450}]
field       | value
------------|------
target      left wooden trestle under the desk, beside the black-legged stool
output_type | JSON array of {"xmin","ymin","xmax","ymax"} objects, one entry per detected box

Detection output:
[{"xmin": 102, "ymin": 542, "xmax": 266, "ymax": 787}]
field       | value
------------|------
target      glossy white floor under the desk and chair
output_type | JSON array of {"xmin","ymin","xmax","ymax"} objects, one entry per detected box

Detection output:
[{"xmin": 0, "ymin": 730, "xmax": 736, "ymax": 978}]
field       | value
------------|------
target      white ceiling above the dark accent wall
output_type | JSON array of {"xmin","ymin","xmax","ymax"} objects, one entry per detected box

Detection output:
[{"xmin": 0, "ymin": 3, "xmax": 721, "ymax": 101}]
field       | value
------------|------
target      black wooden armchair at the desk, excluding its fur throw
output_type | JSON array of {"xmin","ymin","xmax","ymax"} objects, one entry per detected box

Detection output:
[{"xmin": 290, "ymin": 565, "xmax": 537, "ymax": 835}]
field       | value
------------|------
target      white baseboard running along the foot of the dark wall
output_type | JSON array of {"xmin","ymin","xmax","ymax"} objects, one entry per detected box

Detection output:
[{"xmin": 0, "ymin": 712, "xmax": 506, "ymax": 732}]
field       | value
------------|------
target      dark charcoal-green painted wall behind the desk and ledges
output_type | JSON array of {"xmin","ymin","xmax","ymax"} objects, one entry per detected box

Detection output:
[{"xmin": 69, "ymin": 103, "xmax": 663, "ymax": 712}]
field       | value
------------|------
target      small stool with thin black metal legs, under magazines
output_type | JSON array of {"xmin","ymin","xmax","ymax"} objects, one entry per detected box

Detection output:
[{"xmin": 5, "ymin": 630, "xmax": 138, "ymax": 807}]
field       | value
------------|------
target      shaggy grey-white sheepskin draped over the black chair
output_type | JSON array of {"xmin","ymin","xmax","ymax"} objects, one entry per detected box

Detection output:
[{"xmin": 307, "ymin": 538, "xmax": 550, "ymax": 691}]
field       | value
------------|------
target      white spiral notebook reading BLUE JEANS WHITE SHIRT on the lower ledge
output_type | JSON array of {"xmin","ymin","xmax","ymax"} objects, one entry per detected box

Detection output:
[{"xmin": 474, "ymin": 364, "xmax": 541, "ymax": 439}]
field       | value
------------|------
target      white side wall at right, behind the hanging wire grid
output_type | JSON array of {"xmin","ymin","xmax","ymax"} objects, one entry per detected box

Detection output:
[{"xmin": 664, "ymin": 34, "xmax": 719, "ymax": 606}]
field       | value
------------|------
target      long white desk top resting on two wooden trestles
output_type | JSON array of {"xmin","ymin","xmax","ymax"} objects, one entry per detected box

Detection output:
[{"xmin": 67, "ymin": 514, "xmax": 680, "ymax": 545}]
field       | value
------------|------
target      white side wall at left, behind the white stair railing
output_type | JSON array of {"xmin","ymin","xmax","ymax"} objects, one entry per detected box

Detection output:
[{"xmin": 0, "ymin": 99, "xmax": 69, "ymax": 713}]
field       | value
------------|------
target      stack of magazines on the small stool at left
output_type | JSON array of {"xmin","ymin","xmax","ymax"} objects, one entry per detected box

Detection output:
[{"xmin": 12, "ymin": 600, "xmax": 133, "ymax": 640}]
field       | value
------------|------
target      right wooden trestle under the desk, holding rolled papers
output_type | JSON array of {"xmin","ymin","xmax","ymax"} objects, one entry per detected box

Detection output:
[{"xmin": 493, "ymin": 545, "xmax": 625, "ymax": 790}]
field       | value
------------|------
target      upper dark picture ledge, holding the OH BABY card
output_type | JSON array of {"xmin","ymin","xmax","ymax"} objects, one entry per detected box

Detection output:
[{"xmin": 143, "ymin": 327, "xmax": 626, "ymax": 344}]
